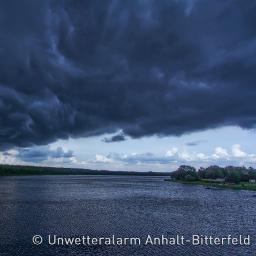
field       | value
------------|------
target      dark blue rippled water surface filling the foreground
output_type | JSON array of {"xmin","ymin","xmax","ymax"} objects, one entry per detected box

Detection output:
[{"xmin": 0, "ymin": 176, "xmax": 256, "ymax": 256}]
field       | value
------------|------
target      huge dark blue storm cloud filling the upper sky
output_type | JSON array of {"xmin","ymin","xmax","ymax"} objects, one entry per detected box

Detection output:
[{"xmin": 0, "ymin": 0, "xmax": 256, "ymax": 148}]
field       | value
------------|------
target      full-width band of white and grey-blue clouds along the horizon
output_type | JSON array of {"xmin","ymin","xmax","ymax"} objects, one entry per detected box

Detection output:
[{"xmin": 0, "ymin": 144, "xmax": 256, "ymax": 171}]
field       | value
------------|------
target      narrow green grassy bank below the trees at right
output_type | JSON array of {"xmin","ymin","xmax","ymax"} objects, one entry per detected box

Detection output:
[{"xmin": 168, "ymin": 180, "xmax": 256, "ymax": 191}]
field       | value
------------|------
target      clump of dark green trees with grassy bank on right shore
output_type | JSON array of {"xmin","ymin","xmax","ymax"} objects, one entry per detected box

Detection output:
[{"xmin": 166, "ymin": 165, "xmax": 256, "ymax": 191}]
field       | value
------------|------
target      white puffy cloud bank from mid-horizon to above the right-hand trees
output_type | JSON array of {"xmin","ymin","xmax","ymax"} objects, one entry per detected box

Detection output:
[{"xmin": 92, "ymin": 144, "xmax": 256, "ymax": 167}]
